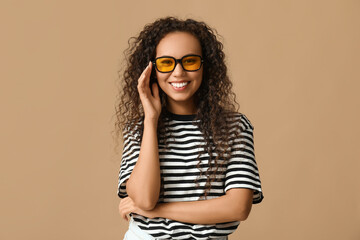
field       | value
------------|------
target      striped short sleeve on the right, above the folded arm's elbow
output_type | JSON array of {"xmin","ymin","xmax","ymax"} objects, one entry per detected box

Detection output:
[{"xmin": 225, "ymin": 114, "xmax": 264, "ymax": 204}]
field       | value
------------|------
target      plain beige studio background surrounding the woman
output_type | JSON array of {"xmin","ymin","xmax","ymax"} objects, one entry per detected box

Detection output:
[{"xmin": 0, "ymin": 0, "xmax": 360, "ymax": 240}]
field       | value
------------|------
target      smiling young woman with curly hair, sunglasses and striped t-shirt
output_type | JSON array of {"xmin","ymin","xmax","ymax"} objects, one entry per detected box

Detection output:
[{"xmin": 116, "ymin": 17, "xmax": 263, "ymax": 240}]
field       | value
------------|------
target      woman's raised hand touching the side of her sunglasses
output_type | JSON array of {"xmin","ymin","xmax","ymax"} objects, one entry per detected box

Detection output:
[{"xmin": 137, "ymin": 62, "xmax": 161, "ymax": 121}]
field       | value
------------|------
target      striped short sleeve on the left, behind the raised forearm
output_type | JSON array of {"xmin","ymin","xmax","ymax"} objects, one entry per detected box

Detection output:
[{"xmin": 117, "ymin": 124, "xmax": 141, "ymax": 198}]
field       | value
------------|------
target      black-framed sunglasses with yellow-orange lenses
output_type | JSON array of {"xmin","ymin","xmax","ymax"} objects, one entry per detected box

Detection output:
[{"xmin": 153, "ymin": 54, "xmax": 204, "ymax": 73}]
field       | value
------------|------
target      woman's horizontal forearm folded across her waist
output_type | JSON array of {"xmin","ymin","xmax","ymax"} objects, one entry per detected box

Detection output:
[{"xmin": 153, "ymin": 192, "xmax": 249, "ymax": 224}]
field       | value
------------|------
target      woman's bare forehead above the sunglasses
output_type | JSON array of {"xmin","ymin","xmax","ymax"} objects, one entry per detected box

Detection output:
[{"xmin": 156, "ymin": 32, "xmax": 201, "ymax": 58}]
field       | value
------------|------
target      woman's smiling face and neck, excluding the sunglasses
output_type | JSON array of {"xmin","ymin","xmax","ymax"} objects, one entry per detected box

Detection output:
[{"xmin": 156, "ymin": 32, "xmax": 203, "ymax": 114}]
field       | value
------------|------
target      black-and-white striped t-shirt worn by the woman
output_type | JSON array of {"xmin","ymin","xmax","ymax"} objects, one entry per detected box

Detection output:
[{"xmin": 118, "ymin": 109, "xmax": 263, "ymax": 240}]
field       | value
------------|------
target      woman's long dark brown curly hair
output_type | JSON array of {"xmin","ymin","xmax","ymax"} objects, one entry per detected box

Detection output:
[{"xmin": 115, "ymin": 17, "xmax": 240, "ymax": 199}]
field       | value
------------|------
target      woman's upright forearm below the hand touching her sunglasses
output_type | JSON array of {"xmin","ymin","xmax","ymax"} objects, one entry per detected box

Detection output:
[{"xmin": 126, "ymin": 119, "xmax": 161, "ymax": 210}]
